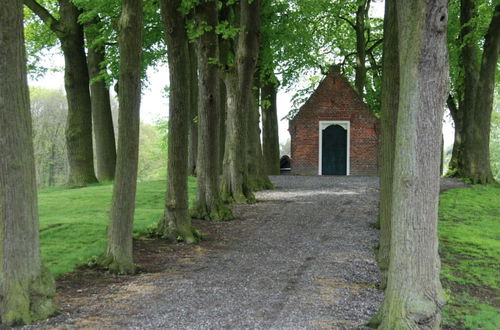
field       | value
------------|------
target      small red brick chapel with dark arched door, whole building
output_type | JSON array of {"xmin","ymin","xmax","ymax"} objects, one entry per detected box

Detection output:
[{"xmin": 289, "ymin": 66, "xmax": 378, "ymax": 176}]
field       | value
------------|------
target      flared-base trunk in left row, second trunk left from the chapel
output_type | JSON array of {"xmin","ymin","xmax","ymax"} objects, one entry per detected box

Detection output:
[{"xmin": 247, "ymin": 82, "xmax": 273, "ymax": 191}]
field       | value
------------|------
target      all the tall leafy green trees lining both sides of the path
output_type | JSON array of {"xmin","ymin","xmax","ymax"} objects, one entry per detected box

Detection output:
[{"xmin": 0, "ymin": 0, "xmax": 500, "ymax": 329}]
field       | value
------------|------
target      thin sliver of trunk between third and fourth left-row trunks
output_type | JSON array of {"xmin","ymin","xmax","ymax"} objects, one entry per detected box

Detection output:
[{"xmin": 188, "ymin": 43, "xmax": 198, "ymax": 176}]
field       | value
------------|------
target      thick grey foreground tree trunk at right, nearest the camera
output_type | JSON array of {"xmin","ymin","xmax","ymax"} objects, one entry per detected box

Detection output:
[{"xmin": 379, "ymin": 0, "xmax": 448, "ymax": 329}]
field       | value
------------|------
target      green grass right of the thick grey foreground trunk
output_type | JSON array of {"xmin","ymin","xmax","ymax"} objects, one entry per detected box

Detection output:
[{"xmin": 439, "ymin": 185, "xmax": 500, "ymax": 329}]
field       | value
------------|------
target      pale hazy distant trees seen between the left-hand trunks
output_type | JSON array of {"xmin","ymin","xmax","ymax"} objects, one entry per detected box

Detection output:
[{"xmin": 30, "ymin": 87, "xmax": 167, "ymax": 187}]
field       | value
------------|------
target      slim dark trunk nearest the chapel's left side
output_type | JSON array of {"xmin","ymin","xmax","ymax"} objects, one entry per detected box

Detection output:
[{"xmin": 261, "ymin": 75, "xmax": 280, "ymax": 175}]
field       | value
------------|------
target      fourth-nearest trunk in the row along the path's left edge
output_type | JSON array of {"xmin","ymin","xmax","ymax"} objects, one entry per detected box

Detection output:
[{"xmin": 192, "ymin": 0, "xmax": 233, "ymax": 221}]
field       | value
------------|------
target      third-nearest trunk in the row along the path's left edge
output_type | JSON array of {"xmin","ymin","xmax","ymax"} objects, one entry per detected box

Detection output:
[{"xmin": 159, "ymin": 0, "xmax": 196, "ymax": 243}]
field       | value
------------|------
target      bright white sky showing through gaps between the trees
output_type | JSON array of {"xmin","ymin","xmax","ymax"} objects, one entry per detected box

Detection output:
[{"xmin": 29, "ymin": 1, "xmax": 454, "ymax": 147}]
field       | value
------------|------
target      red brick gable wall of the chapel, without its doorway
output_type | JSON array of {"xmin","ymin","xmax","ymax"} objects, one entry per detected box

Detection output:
[{"xmin": 289, "ymin": 69, "xmax": 378, "ymax": 176}]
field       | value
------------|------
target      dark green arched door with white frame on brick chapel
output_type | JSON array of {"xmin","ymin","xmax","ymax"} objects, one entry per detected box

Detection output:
[{"xmin": 320, "ymin": 122, "xmax": 349, "ymax": 175}]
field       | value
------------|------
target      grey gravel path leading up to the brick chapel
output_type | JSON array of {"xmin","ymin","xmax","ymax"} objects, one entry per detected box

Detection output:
[{"xmin": 19, "ymin": 176, "xmax": 464, "ymax": 329}]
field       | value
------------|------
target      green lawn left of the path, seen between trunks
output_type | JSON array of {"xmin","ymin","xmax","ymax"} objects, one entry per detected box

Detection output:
[{"xmin": 38, "ymin": 178, "xmax": 196, "ymax": 276}]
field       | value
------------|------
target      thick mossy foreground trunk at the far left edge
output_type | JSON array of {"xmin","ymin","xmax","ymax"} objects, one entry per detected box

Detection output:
[{"xmin": 0, "ymin": 0, "xmax": 55, "ymax": 325}]
